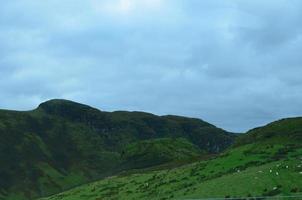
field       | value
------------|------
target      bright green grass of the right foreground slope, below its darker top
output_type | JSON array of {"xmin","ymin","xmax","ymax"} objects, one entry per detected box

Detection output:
[{"xmin": 39, "ymin": 142, "xmax": 302, "ymax": 200}]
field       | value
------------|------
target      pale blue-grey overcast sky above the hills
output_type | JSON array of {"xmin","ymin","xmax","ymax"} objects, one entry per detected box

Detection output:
[{"xmin": 0, "ymin": 0, "xmax": 302, "ymax": 132}]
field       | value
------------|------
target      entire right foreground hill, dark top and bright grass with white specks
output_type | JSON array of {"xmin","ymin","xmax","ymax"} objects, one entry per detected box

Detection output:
[{"xmin": 43, "ymin": 118, "xmax": 302, "ymax": 200}]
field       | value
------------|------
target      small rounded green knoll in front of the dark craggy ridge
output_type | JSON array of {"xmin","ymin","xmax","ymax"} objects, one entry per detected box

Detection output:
[{"xmin": 121, "ymin": 138, "xmax": 206, "ymax": 169}]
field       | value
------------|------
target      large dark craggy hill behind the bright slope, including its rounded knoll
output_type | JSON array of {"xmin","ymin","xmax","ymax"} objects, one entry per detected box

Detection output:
[{"xmin": 0, "ymin": 100, "xmax": 235, "ymax": 200}]
